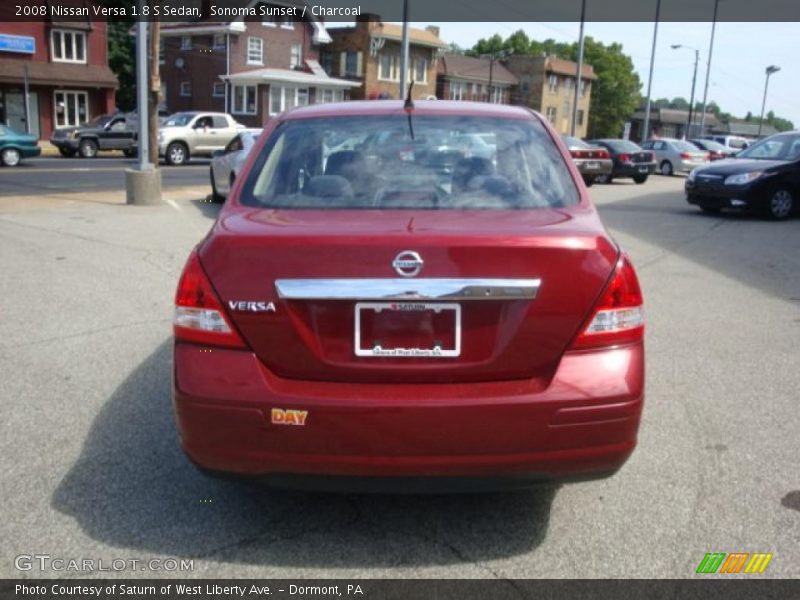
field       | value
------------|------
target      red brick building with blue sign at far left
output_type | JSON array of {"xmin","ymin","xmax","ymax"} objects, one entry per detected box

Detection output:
[{"xmin": 0, "ymin": 12, "xmax": 118, "ymax": 139}]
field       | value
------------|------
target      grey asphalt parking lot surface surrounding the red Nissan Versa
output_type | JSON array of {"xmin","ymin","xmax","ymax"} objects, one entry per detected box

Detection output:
[{"xmin": 0, "ymin": 172, "xmax": 800, "ymax": 578}]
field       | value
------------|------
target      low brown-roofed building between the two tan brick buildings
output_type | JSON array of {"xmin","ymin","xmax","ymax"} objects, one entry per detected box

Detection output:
[{"xmin": 436, "ymin": 54, "xmax": 519, "ymax": 104}]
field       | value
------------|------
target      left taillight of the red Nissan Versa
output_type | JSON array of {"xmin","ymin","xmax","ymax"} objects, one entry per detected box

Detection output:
[{"xmin": 172, "ymin": 251, "xmax": 247, "ymax": 348}]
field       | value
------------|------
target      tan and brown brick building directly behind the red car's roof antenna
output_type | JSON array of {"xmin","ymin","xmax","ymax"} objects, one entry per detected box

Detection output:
[{"xmin": 320, "ymin": 14, "xmax": 447, "ymax": 100}]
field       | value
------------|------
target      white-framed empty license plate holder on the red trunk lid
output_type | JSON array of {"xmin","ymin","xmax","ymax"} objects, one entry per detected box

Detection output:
[{"xmin": 354, "ymin": 301, "xmax": 461, "ymax": 358}]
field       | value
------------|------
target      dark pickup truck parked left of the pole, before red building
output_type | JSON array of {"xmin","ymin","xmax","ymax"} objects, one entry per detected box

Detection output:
[{"xmin": 50, "ymin": 113, "xmax": 137, "ymax": 158}]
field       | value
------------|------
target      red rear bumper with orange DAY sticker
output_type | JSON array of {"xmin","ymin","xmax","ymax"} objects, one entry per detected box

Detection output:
[{"xmin": 173, "ymin": 343, "xmax": 644, "ymax": 485}]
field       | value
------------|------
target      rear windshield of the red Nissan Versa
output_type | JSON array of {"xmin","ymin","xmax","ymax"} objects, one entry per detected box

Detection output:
[{"xmin": 240, "ymin": 113, "xmax": 579, "ymax": 210}]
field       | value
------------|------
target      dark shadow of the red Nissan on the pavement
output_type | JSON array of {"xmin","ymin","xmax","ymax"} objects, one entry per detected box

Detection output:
[{"xmin": 51, "ymin": 341, "xmax": 558, "ymax": 569}]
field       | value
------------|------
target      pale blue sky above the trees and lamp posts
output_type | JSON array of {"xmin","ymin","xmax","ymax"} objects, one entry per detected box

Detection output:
[{"xmin": 412, "ymin": 22, "xmax": 800, "ymax": 129}]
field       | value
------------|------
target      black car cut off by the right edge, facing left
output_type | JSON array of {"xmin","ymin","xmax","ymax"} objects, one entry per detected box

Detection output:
[{"xmin": 685, "ymin": 131, "xmax": 800, "ymax": 220}]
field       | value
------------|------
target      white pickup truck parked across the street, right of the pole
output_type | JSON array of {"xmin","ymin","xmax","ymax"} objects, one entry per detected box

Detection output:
[{"xmin": 158, "ymin": 112, "xmax": 245, "ymax": 165}]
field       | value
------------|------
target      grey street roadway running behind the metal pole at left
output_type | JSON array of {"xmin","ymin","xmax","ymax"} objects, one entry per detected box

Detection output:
[{"xmin": 0, "ymin": 153, "xmax": 210, "ymax": 198}]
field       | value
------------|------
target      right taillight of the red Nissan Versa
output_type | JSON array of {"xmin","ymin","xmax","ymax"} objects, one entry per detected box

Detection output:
[{"xmin": 570, "ymin": 255, "xmax": 644, "ymax": 350}]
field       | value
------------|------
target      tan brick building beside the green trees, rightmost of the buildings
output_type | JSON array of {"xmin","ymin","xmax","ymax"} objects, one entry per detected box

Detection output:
[{"xmin": 503, "ymin": 56, "xmax": 597, "ymax": 137}]
